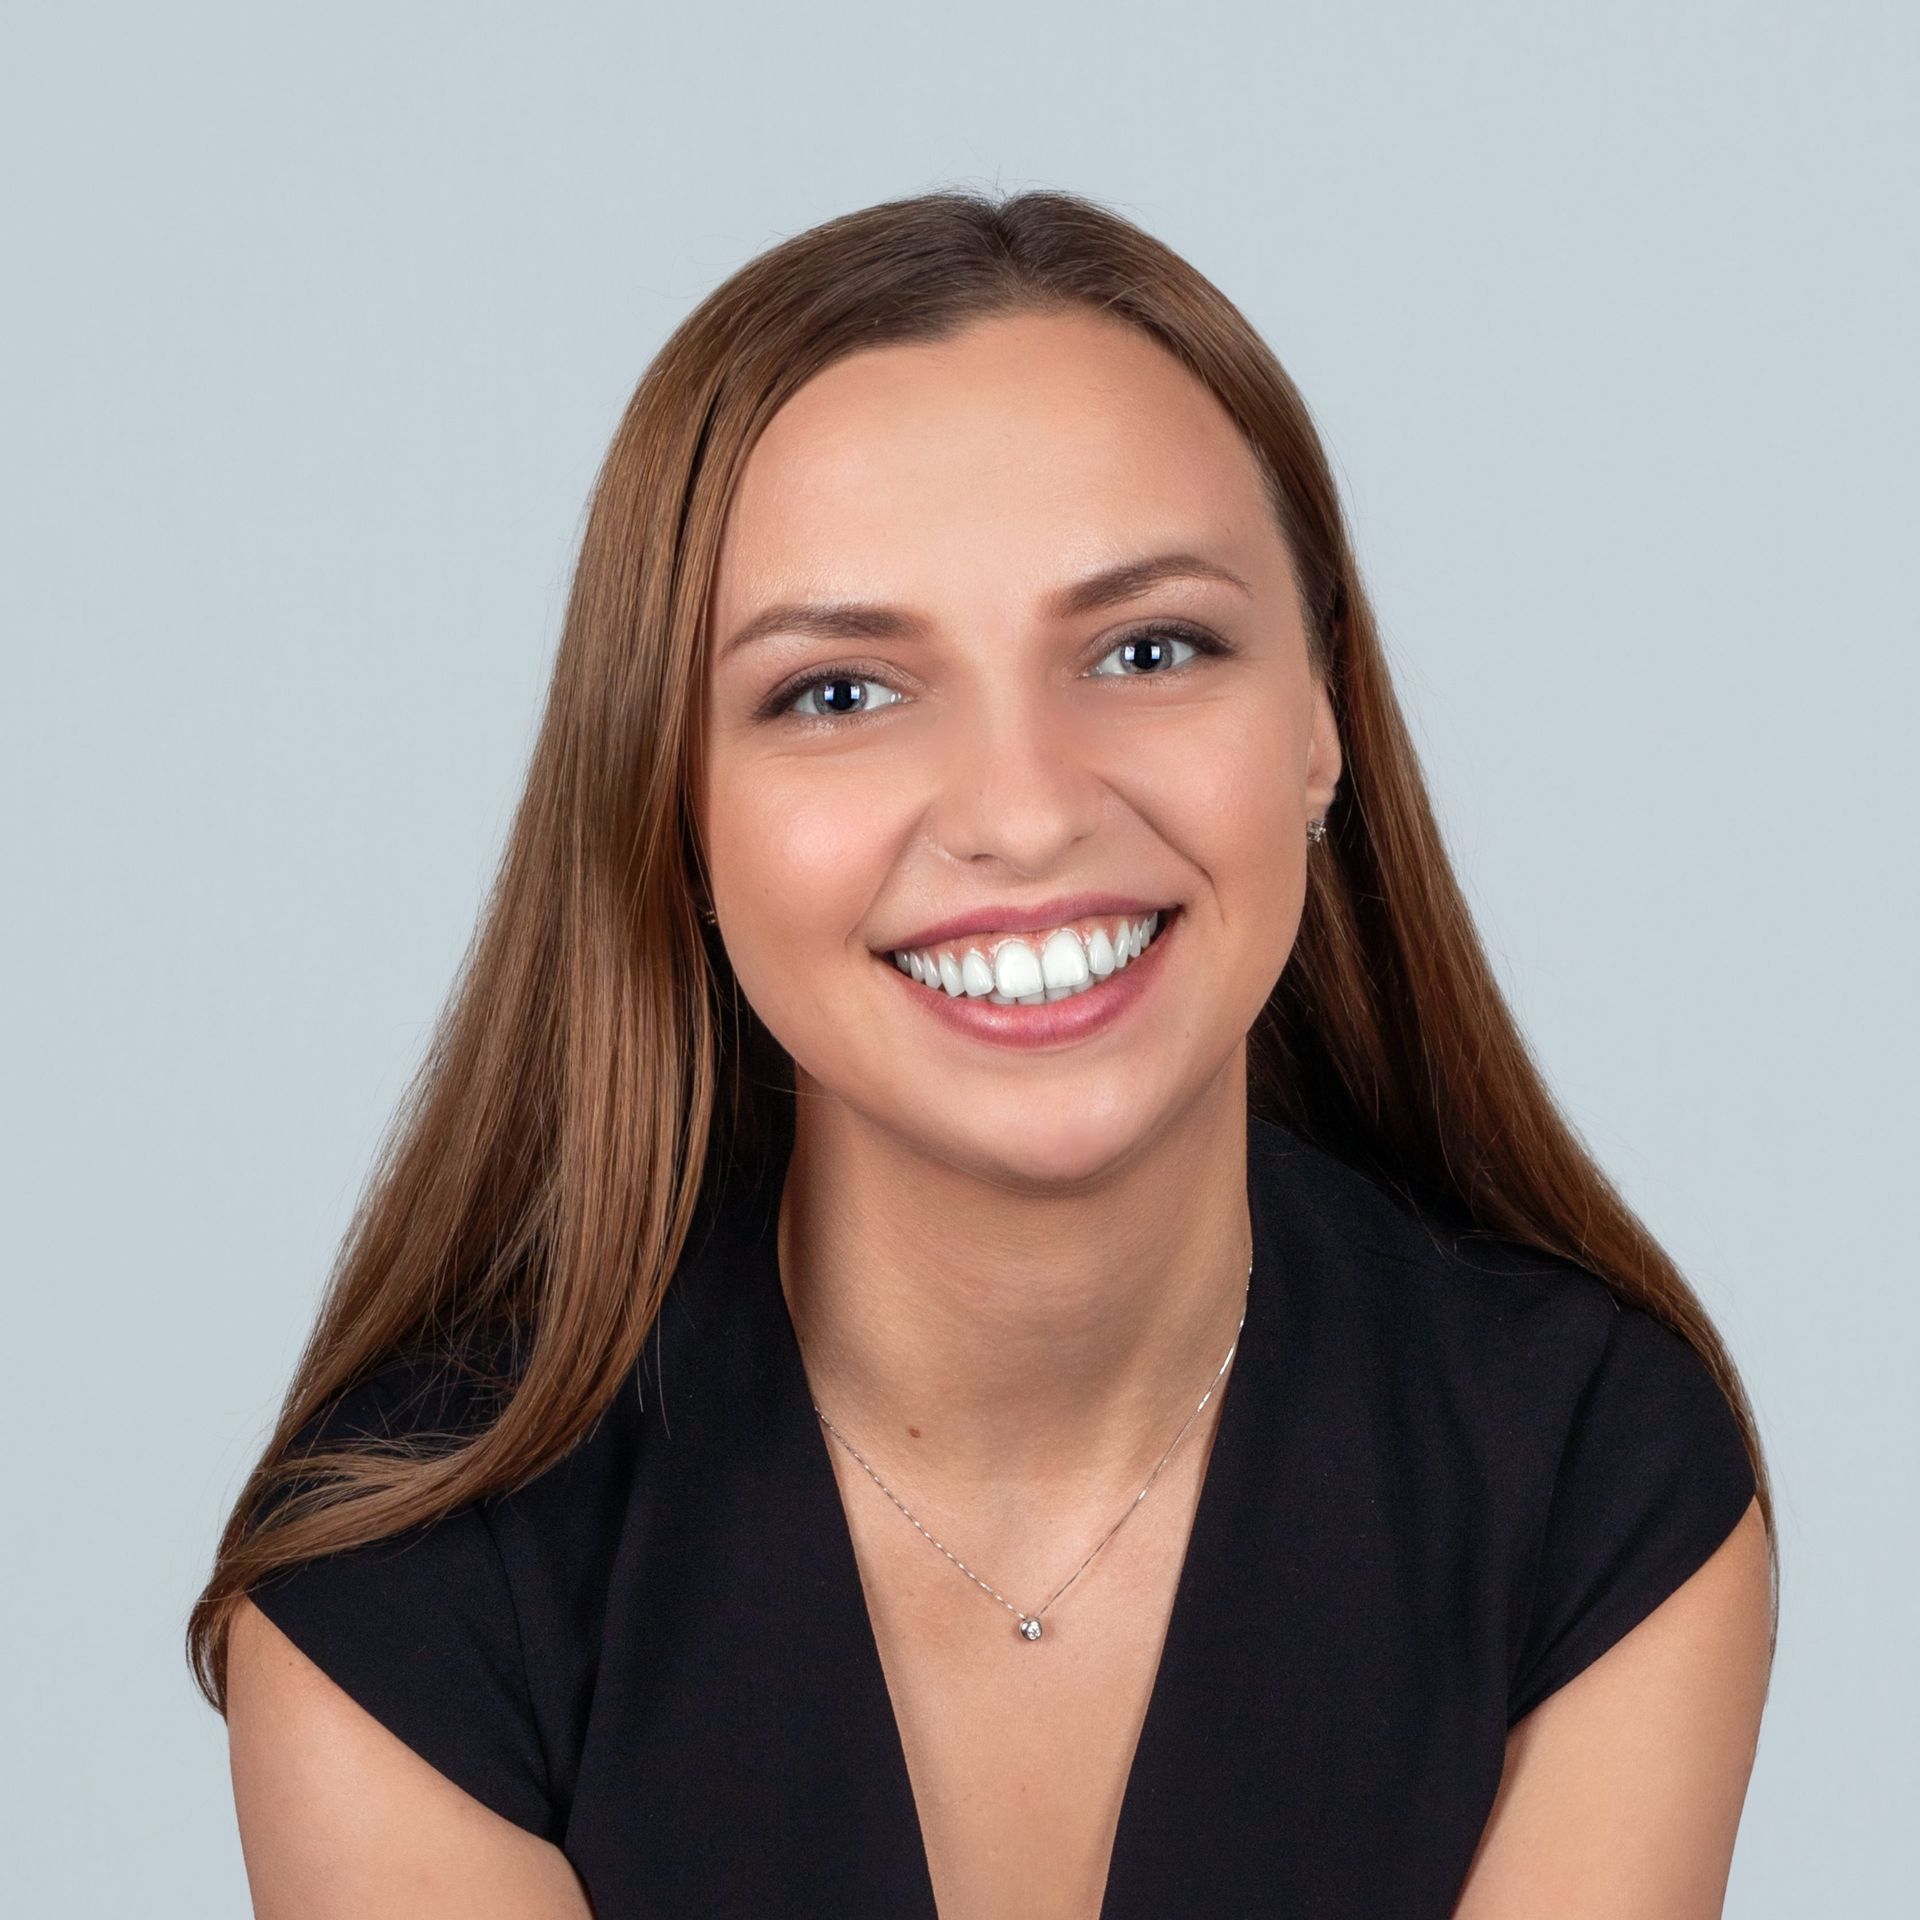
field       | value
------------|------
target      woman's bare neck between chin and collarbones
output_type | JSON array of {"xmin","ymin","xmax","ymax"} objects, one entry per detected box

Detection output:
[{"xmin": 780, "ymin": 1075, "xmax": 1252, "ymax": 1505}]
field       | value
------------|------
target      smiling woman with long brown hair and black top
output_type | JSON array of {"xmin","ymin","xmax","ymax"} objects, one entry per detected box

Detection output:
[{"xmin": 190, "ymin": 183, "xmax": 1774, "ymax": 1920}]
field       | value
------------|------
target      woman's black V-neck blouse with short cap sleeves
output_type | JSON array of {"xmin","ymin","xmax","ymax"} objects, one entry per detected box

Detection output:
[{"xmin": 253, "ymin": 1117, "xmax": 1755, "ymax": 1920}]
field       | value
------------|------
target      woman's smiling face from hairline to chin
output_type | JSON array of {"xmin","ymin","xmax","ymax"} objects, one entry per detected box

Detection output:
[{"xmin": 699, "ymin": 313, "xmax": 1340, "ymax": 1187}]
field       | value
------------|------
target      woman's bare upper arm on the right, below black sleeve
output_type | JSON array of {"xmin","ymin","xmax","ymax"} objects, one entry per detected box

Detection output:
[{"xmin": 1453, "ymin": 1501, "xmax": 1770, "ymax": 1920}]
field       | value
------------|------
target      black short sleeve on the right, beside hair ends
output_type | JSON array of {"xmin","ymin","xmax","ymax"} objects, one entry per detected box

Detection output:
[{"xmin": 1507, "ymin": 1306, "xmax": 1755, "ymax": 1726}]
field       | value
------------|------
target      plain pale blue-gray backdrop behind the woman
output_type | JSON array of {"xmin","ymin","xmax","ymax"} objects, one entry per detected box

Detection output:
[{"xmin": 0, "ymin": 0, "xmax": 1920, "ymax": 1920}]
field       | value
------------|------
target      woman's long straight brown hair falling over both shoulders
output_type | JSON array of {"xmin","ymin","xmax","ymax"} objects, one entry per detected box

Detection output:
[{"xmin": 186, "ymin": 190, "xmax": 1778, "ymax": 1713}]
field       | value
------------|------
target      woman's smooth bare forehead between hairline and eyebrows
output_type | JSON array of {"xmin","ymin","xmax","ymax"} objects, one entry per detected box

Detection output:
[{"xmin": 714, "ymin": 313, "xmax": 1286, "ymax": 632}]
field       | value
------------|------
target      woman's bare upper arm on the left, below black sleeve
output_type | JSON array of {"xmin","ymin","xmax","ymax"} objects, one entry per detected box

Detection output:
[{"xmin": 227, "ymin": 1601, "xmax": 591, "ymax": 1920}]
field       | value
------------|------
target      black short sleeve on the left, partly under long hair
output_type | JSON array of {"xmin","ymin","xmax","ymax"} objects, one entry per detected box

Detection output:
[{"xmin": 250, "ymin": 1365, "xmax": 561, "ymax": 1841}]
